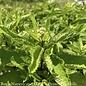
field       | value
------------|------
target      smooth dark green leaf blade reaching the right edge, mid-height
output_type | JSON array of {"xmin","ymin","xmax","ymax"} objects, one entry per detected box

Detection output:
[{"xmin": 58, "ymin": 52, "xmax": 86, "ymax": 65}]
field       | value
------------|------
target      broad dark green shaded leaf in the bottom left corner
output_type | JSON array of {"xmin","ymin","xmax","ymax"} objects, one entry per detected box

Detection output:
[{"xmin": 0, "ymin": 67, "xmax": 23, "ymax": 83}]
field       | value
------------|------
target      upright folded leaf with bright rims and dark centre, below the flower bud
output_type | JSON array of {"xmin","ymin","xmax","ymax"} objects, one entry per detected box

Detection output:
[{"xmin": 28, "ymin": 46, "xmax": 44, "ymax": 73}]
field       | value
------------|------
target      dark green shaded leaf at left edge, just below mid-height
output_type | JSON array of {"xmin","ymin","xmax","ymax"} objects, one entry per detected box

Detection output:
[{"xmin": 0, "ymin": 49, "xmax": 27, "ymax": 64}]
